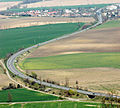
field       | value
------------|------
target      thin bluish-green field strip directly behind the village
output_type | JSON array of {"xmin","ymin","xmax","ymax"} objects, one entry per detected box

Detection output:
[{"xmin": 7, "ymin": 4, "xmax": 111, "ymax": 12}]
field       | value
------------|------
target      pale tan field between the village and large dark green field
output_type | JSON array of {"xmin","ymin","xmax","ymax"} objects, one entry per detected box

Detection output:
[{"xmin": 0, "ymin": 17, "xmax": 95, "ymax": 29}]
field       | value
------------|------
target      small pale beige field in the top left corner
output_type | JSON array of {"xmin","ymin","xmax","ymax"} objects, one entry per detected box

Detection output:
[{"xmin": 0, "ymin": 1, "xmax": 21, "ymax": 11}]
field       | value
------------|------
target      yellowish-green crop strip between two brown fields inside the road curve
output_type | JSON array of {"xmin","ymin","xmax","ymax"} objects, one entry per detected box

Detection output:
[{"xmin": 19, "ymin": 53, "xmax": 120, "ymax": 70}]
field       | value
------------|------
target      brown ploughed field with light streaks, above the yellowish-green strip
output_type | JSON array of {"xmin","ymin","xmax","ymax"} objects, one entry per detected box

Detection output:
[{"xmin": 28, "ymin": 28, "xmax": 120, "ymax": 58}]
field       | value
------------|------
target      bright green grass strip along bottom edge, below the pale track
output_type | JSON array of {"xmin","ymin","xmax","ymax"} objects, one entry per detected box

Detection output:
[{"xmin": 0, "ymin": 101, "xmax": 99, "ymax": 108}]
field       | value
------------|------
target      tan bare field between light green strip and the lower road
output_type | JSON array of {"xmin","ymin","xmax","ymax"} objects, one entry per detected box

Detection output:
[{"xmin": 28, "ymin": 68, "xmax": 120, "ymax": 91}]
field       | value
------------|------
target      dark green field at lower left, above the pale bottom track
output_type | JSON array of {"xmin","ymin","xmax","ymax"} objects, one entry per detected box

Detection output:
[{"xmin": 0, "ymin": 89, "xmax": 59, "ymax": 101}]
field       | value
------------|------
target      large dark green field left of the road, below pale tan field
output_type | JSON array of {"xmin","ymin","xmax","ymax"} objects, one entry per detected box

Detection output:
[{"xmin": 0, "ymin": 23, "xmax": 84, "ymax": 58}]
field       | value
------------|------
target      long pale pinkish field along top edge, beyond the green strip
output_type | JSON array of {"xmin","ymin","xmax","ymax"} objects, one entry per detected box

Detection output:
[{"xmin": 22, "ymin": 0, "xmax": 120, "ymax": 8}]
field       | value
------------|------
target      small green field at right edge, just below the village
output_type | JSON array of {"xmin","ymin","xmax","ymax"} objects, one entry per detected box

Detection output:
[{"xmin": 94, "ymin": 20, "xmax": 120, "ymax": 29}]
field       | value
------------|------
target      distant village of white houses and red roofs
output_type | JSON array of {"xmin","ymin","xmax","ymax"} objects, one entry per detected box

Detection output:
[{"xmin": 2, "ymin": 4, "xmax": 120, "ymax": 21}]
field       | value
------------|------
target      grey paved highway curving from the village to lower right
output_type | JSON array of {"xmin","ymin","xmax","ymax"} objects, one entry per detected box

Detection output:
[{"xmin": 7, "ymin": 9, "xmax": 120, "ymax": 98}]
